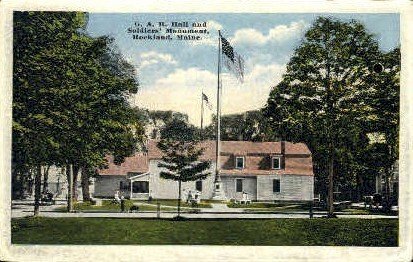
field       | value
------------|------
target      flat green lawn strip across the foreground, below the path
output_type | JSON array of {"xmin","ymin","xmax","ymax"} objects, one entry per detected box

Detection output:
[{"xmin": 11, "ymin": 217, "xmax": 398, "ymax": 246}]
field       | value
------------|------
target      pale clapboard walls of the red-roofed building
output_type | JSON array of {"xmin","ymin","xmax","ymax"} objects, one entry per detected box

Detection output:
[{"xmin": 94, "ymin": 160, "xmax": 314, "ymax": 201}]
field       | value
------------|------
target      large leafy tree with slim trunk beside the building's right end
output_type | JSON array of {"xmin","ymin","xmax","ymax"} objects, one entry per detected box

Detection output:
[{"xmin": 263, "ymin": 17, "xmax": 396, "ymax": 216}]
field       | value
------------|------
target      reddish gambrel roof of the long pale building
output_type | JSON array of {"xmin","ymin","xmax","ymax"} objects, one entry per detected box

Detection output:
[{"xmin": 99, "ymin": 140, "xmax": 314, "ymax": 175}]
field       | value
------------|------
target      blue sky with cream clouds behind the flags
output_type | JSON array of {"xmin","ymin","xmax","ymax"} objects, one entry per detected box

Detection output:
[{"xmin": 87, "ymin": 13, "xmax": 400, "ymax": 126}]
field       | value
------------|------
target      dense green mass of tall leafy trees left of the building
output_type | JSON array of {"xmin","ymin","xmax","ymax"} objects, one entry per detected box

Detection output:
[{"xmin": 13, "ymin": 12, "xmax": 142, "ymax": 214}]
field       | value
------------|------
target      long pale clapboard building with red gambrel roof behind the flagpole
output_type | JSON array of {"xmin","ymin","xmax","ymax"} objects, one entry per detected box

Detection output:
[{"xmin": 94, "ymin": 140, "xmax": 314, "ymax": 201}]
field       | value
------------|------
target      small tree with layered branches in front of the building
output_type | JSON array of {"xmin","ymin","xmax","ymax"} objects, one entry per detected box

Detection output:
[{"xmin": 157, "ymin": 139, "xmax": 211, "ymax": 218}]
